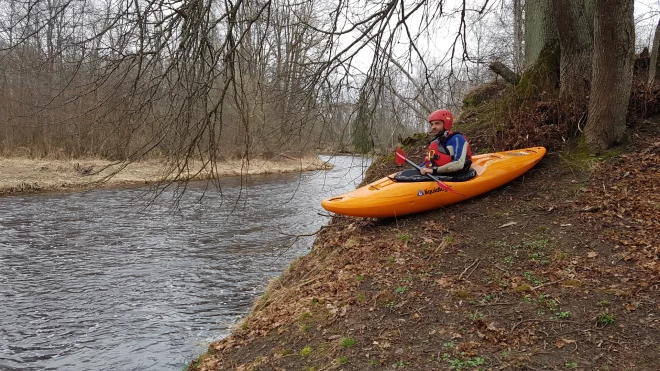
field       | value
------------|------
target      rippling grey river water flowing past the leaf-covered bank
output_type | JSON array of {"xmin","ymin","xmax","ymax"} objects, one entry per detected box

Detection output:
[{"xmin": 0, "ymin": 156, "xmax": 369, "ymax": 370}]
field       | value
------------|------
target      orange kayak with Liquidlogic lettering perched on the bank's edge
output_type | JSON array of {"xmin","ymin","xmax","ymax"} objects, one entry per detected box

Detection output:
[{"xmin": 321, "ymin": 147, "xmax": 545, "ymax": 218}]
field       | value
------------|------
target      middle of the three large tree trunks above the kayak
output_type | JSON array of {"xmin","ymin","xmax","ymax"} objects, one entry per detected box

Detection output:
[{"xmin": 552, "ymin": 0, "xmax": 593, "ymax": 135}]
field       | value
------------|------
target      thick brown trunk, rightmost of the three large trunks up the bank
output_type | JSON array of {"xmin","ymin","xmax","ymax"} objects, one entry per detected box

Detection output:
[{"xmin": 584, "ymin": 0, "xmax": 635, "ymax": 153}]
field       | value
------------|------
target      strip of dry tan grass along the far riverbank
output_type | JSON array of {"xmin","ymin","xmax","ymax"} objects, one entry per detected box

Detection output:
[{"xmin": 0, "ymin": 156, "xmax": 331, "ymax": 196}]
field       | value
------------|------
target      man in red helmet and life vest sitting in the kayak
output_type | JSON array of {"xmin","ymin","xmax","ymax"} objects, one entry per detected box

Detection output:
[{"xmin": 420, "ymin": 109, "xmax": 472, "ymax": 175}]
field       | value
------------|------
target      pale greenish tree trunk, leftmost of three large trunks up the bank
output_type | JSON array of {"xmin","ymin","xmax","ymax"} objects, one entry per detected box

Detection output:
[{"xmin": 525, "ymin": 0, "xmax": 557, "ymax": 68}]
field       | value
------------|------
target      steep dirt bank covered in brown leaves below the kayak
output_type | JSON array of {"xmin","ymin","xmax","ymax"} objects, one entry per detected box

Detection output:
[{"xmin": 190, "ymin": 124, "xmax": 660, "ymax": 370}]
